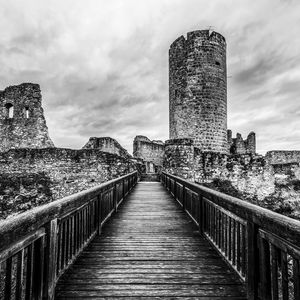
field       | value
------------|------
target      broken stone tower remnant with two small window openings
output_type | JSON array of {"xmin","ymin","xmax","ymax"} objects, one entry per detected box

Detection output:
[{"xmin": 0, "ymin": 83, "xmax": 54, "ymax": 152}]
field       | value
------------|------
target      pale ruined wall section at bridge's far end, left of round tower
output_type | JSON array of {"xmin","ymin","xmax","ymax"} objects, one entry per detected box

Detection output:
[{"xmin": 133, "ymin": 135, "xmax": 165, "ymax": 166}]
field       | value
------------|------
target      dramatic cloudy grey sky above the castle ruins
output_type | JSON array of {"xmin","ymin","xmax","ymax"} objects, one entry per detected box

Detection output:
[{"xmin": 0, "ymin": 0, "xmax": 300, "ymax": 153}]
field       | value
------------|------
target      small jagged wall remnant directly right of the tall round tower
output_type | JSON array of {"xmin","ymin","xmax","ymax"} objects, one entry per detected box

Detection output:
[{"xmin": 227, "ymin": 130, "xmax": 256, "ymax": 155}]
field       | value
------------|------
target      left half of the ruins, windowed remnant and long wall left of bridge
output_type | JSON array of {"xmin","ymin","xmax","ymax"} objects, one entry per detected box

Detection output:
[{"xmin": 0, "ymin": 83, "xmax": 139, "ymax": 219}]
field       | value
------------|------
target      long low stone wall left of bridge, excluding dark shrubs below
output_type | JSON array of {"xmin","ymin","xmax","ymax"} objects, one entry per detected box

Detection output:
[{"xmin": 0, "ymin": 148, "xmax": 137, "ymax": 202}]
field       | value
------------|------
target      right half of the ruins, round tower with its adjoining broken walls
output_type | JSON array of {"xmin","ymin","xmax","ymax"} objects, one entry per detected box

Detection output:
[{"xmin": 133, "ymin": 30, "xmax": 300, "ymax": 213}]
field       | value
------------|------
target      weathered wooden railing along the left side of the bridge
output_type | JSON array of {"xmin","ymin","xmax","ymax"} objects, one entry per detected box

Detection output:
[{"xmin": 0, "ymin": 172, "xmax": 137, "ymax": 300}]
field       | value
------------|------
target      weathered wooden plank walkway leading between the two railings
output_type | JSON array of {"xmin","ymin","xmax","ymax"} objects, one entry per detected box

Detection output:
[{"xmin": 56, "ymin": 182, "xmax": 246, "ymax": 300}]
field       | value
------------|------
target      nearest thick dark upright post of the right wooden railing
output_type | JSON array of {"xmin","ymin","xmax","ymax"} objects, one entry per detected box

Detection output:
[{"xmin": 246, "ymin": 222, "xmax": 259, "ymax": 300}]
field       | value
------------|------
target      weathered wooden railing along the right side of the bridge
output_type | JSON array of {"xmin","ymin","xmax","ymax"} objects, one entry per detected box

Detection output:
[{"xmin": 161, "ymin": 173, "xmax": 300, "ymax": 300}]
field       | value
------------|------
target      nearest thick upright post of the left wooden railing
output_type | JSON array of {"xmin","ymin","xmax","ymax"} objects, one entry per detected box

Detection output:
[{"xmin": 43, "ymin": 219, "xmax": 58, "ymax": 300}]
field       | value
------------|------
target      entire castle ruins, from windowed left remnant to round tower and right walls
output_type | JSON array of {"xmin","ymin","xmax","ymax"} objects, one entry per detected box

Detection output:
[{"xmin": 0, "ymin": 30, "xmax": 300, "ymax": 217}]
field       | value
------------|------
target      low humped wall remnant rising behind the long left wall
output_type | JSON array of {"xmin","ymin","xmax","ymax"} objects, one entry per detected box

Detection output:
[{"xmin": 82, "ymin": 137, "xmax": 131, "ymax": 158}]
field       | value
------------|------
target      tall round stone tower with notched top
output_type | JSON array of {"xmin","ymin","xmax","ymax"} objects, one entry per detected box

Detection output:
[{"xmin": 169, "ymin": 30, "xmax": 228, "ymax": 153}]
